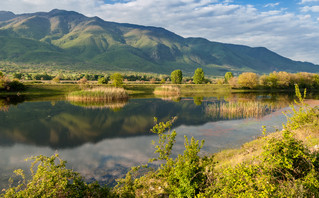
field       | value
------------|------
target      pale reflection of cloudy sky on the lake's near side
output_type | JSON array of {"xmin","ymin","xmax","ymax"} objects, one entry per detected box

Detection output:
[{"xmin": 0, "ymin": 107, "xmax": 286, "ymax": 188}]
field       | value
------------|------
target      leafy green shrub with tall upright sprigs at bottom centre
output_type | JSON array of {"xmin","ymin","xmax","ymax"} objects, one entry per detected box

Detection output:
[{"xmin": 116, "ymin": 118, "xmax": 213, "ymax": 197}]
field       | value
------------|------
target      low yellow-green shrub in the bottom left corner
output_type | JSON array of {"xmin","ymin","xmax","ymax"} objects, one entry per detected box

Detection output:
[{"xmin": 2, "ymin": 154, "xmax": 114, "ymax": 197}]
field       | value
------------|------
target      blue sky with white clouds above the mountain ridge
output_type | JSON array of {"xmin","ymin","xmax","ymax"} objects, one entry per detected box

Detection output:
[{"xmin": 0, "ymin": 0, "xmax": 319, "ymax": 64}]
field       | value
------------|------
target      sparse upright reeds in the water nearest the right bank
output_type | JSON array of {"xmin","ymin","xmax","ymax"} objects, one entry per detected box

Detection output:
[{"xmin": 206, "ymin": 101, "xmax": 283, "ymax": 119}]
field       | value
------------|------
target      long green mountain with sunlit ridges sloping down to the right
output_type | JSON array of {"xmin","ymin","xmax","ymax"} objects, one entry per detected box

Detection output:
[{"xmin": 0, "ymin": 9, "xmax": 319, "ymax": 75}]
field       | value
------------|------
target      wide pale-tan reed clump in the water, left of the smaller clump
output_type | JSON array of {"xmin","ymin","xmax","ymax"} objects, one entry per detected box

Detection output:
[{"xmin": 67, "ymin": 87, "xmax": 128, "ymax": 101}]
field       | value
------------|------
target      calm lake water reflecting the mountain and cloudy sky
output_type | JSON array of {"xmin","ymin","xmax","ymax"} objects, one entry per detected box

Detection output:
[{"xmin": 0, "ymin": 94, "xmax": 315, "ymax": 188}]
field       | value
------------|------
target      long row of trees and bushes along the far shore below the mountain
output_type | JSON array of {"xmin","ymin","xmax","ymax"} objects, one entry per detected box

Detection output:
[{"xmin": 3, "ymin": 68, "xmax": 319, "ymax": 89}]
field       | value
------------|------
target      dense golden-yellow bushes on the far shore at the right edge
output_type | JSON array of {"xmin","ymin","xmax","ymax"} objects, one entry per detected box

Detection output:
[{"xmin": 229, "ymin": 71, "xmax": 319, "ymax": 89}]
